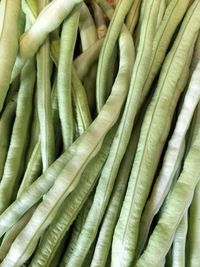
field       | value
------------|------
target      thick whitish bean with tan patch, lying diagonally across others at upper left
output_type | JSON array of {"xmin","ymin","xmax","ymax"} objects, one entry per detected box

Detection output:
[{"xmin": 11, "ymin": 0, "xmax": 83, "ymax": 80}]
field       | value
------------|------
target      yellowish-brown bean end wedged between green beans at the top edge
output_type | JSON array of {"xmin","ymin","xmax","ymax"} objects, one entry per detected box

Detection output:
[{"xmin": 126, "ymin": 0, "xmax": 142, "ymax": 34}]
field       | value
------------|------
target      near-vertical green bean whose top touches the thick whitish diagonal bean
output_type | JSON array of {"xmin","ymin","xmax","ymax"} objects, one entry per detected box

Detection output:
[{"xmin": 57, "ymin": 6, "xmax": 80, "ymax": 150}]
